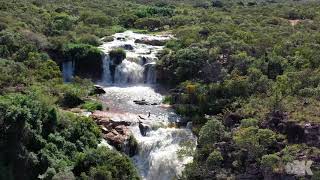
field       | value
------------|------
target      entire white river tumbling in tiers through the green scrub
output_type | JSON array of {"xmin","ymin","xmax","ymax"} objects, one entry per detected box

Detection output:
[{"xmin": 63, "ymin": 31, "xmax": 196, "ymax": 180}]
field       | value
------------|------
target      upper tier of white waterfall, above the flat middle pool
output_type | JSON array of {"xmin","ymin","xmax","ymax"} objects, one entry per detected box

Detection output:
[{"xmin": 100, "ymin": 31, "xmax": 170, "ymax": 84}]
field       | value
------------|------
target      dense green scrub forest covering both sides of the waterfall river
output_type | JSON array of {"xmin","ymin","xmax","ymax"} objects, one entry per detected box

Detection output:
[{"xmin": 0, "ymin": 0, "xmax": 320, "ymax": 180}]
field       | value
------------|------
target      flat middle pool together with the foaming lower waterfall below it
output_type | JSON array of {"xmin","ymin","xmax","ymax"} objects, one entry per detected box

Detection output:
[{"xmin": 102, "ymin": 86, "xmax": 196, "ymax": 180}]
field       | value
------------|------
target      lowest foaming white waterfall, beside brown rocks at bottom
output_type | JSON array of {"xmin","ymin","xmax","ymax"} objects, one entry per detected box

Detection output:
[{"xmin": 132, "ymin": 127, "xmax": 195, "ymax": 180}]
